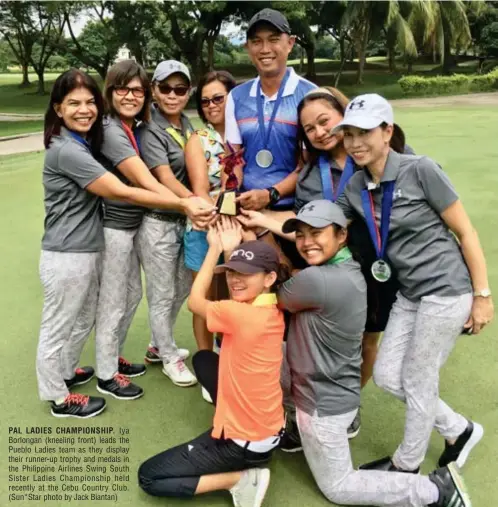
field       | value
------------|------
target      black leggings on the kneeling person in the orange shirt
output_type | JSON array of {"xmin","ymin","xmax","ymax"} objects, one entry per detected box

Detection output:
[{"xmin": 138, "ymin": 350, "xmax": 272, "ymax": 497}]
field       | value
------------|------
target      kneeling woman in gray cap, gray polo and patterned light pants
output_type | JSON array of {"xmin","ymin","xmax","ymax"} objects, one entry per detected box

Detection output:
[{"xmin": 278, "ymin": 200, "xmax": 470, "ymax": 507}]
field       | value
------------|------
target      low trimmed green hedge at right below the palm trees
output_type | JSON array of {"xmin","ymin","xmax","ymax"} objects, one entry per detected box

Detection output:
[{"xmin": 398, "ymin": 69, "xmax": 498, "ymax": 95}]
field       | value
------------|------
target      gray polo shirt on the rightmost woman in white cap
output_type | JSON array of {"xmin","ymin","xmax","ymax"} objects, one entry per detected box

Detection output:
[{"xmin": 337, "ymin": 150, "xmax": 472, "ymax": 301}]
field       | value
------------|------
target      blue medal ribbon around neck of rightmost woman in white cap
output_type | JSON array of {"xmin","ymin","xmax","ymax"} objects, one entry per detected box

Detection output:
[{"xmin": 361, "ymin": 181, "xmax": 395, "ymax": 259}]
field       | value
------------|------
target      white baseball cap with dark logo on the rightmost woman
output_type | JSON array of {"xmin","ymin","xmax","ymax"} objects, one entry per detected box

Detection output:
[{"xmin": 332, "ymin": 93, "xmax": 394, "ymax": 132}]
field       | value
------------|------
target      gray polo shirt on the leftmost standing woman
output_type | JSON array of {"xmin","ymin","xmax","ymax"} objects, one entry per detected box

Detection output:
[{"xmin": 42, "ymin": 128, "xmax": 107, "ymax": 252}]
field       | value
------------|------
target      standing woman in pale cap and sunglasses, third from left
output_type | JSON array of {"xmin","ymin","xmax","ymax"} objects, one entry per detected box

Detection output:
[{"xmin": 138, "ymin": 60, "xmax": 197, "ymax": 387}]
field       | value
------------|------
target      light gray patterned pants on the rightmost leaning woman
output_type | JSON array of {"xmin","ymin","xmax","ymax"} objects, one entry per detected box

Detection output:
[{"xmin": 373, "ymin": 293, "xmax": 473, "ymax": 470}]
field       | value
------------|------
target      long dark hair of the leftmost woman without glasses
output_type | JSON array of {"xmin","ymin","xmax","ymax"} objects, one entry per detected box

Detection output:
[{"xmin": 43, "ymin": 69, "xmax": 104, "ymax": 154}]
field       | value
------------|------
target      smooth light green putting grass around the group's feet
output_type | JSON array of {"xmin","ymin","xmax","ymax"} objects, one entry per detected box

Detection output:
[{"xmin": 0, "ymin": 107, "xmax": 498, "ymax": 507}]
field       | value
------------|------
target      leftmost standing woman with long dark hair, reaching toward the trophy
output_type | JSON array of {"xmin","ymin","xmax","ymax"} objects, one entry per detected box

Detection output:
[{"xmin": 36, "ymin": 69, "xmax": 211, "ymax": 417}]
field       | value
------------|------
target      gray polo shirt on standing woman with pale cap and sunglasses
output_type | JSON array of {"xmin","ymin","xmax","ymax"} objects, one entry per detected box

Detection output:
[{"xmin": 137, "ymin": 106, "xmax": 194, "ymax": 216}]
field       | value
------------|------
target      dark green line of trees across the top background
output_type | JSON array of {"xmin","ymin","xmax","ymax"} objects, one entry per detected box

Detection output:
[{"xmin": 0, "ymin": 0, "xmax": 498, "ymax": 93}]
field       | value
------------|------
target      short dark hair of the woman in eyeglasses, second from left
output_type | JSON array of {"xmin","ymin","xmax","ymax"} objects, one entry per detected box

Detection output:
[{"xmin": 104, "ymin": 60, "xmax": 152, "ymax": 121}]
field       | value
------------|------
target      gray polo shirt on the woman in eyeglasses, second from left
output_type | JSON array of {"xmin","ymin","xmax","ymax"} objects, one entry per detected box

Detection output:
[{"xmin": 100, "ymin": 117, "xmax": 144, "ymax": 229}]
